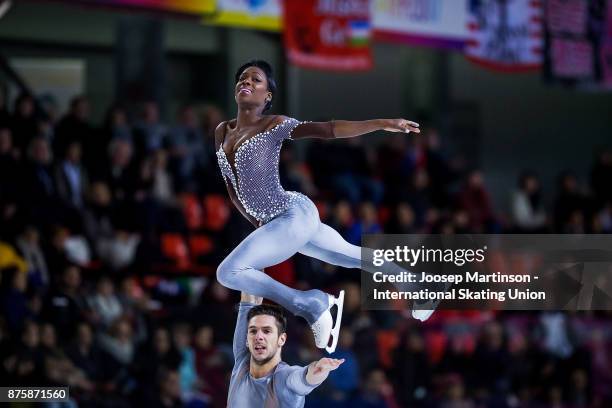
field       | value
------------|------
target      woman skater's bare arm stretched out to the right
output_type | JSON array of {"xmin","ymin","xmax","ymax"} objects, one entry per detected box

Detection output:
[{"xmin": 291, "ymin": 119, "xmax": 420, "ymax": 139}]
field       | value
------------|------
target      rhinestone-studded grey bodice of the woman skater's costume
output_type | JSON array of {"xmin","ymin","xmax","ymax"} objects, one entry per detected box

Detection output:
[{"xmin": 217, "ymin": 118, "xmax": 304, "ymax": 223}]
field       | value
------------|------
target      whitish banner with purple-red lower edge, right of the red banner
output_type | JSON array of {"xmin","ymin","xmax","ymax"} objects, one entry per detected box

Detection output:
[{"xmin": 371, "ymin": 0, "xmax": 468, "ymax": 50}]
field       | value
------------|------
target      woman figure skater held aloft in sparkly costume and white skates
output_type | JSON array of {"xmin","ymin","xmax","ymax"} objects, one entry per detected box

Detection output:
[{"xmin": 215, "ymin": 61, "xmax": 419, "ymax": 353}]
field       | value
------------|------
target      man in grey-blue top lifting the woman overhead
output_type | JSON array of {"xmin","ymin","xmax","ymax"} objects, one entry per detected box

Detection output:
[{"xmin": 227, "ymin": 292, "xmax": 344, "ymax": 408}]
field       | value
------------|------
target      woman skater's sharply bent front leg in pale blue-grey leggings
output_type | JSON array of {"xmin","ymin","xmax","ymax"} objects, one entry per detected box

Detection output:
[{"xmin": 217, "ymin": 203, "xmax": 329, "ymax": 325}]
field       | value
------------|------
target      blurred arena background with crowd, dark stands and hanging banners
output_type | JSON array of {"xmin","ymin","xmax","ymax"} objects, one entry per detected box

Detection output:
[{"xmin": 0, "ymin": 0, "xmax": 612, "ymax": 408}]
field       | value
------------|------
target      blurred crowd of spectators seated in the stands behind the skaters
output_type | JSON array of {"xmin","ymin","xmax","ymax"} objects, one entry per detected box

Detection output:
[{"xmin": 0, "ymin": 94, "xmax": 612, "ymax": 408}]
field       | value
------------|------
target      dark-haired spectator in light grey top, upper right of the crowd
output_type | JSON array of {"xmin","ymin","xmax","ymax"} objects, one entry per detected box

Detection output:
[{"xmin": 512, "ymin": 171, "xmax": 547, "ymax": 233}]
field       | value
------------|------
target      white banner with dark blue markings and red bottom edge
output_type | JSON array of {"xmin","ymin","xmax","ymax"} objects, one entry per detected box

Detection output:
[{"xmin": 465, "ymin": 0, "xmax": 543, "ymax": 72}]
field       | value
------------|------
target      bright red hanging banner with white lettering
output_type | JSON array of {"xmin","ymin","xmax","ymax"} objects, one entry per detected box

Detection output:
[{"xmin": 284, "ymin": 0, "xmax": 372, "ymax": 71}]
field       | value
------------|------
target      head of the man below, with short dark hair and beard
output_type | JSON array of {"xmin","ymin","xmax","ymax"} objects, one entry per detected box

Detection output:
[{"xmin": 247, "ymin": 305, "xmax": 287, "ymax": 365}]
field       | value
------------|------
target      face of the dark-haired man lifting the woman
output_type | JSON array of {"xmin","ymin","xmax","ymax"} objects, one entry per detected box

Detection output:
[{"xmin": 247, "ymin": 315, "xmax": 287, "ymax": 365}]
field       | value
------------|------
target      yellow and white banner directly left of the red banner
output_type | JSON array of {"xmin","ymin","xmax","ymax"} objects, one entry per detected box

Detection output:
[{"xmin": 204, "ymin": 0, "xmax": 282, "ymax": 32}]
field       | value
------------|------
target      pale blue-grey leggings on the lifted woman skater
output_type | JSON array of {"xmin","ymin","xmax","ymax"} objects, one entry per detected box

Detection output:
[{"xmin": 217, "ymin": 196, "xmax": 414, "ymax": 324}]
